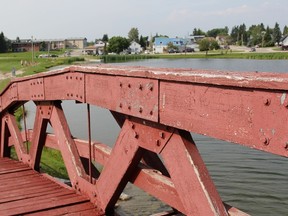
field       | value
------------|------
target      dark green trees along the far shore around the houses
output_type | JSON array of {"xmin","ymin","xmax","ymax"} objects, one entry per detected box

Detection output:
[{"xmin": 0, "ymin": 22, "xmax": 288, "ymax": 53}]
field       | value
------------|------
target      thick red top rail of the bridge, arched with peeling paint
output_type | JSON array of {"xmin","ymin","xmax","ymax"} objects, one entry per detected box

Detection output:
[{"xmin": 0, "ymin": 66, "xmax": 288, "ymax": 157}]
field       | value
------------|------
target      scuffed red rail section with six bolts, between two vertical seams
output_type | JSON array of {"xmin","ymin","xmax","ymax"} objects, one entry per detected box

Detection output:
[{"xmin": 85, "ymin": 74, "xmax": 158, "ymax": 121}]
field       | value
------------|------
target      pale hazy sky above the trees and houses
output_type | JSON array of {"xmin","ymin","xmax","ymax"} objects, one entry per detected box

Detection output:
[{"xmin": 0, "ymin": 0, "xmax": 288, "ymax": 41}]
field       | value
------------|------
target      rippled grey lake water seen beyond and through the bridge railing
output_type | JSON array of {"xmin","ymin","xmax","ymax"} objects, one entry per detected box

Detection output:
[{"xmin": 24, "ymin": 59, "xmax": 288, "ymax": 216}]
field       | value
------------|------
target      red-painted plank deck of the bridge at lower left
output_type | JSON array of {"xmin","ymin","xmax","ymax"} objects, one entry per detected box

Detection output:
[{"xmin": 0, "ymin": 158, "xmax": 97, "ymax": 215}]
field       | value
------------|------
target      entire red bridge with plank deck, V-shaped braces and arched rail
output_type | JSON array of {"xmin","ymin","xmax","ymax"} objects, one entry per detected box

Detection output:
[{"xmin": 0, "ymin": 65, "xmax": 288, "ymax": 216}]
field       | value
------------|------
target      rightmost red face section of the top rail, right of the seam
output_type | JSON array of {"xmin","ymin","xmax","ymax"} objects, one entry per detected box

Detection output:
[{"xmin": 160, "ymin": 82, "xmax": 288, "ymax": 157}]
